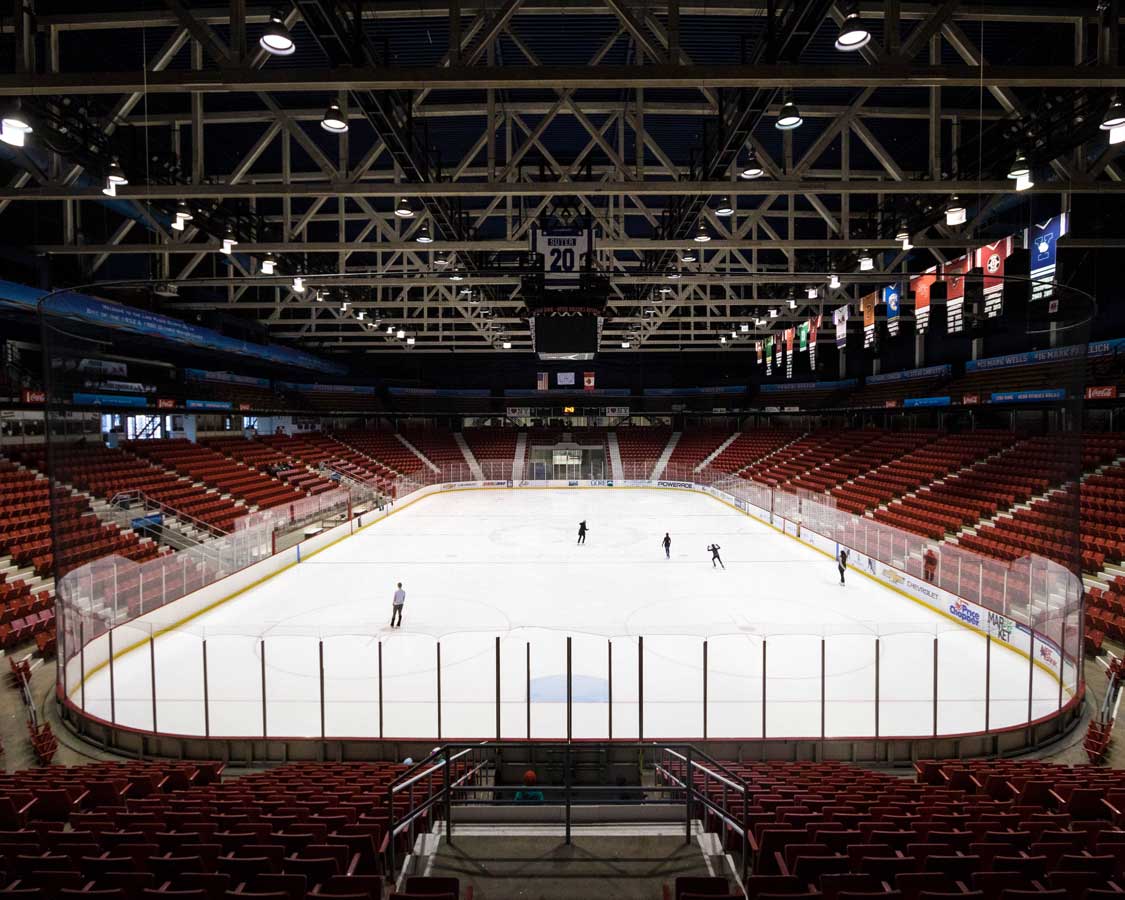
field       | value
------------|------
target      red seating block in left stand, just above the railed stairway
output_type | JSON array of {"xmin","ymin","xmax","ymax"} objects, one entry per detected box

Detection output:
[{"xmin": 15, "ymin": 444, "xmax": 246, "ymax": 531}]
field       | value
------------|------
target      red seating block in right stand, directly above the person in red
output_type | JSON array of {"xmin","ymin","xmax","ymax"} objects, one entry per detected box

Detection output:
[{"xmin": 874, "ymin": 437, "xmax": 1076, "ymax": 539}]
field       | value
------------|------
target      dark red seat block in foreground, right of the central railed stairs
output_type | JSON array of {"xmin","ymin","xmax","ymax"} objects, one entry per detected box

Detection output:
[{"xmin": 658, "ymin": 761, "xmax": 1125, "ymax": 900}]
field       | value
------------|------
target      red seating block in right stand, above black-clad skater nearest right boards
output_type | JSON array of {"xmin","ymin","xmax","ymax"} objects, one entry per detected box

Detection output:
[{"xmin": 831, "ymin": 431, "xmax": 1016, "ymax": 515}]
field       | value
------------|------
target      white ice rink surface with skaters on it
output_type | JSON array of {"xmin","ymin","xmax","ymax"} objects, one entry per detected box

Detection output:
[{"xmin": 81, "ymin": 488, "xmax": 1059, "ymax": 738}]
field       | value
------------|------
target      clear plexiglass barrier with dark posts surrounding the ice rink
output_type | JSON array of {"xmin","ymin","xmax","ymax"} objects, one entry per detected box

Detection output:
[{"xmin": 61, "ymin": 463, "xmax": 1082, "ymax": 739}]
